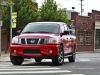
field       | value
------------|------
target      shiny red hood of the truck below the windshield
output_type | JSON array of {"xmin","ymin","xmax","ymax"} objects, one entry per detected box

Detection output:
[{"xmin": 18, "ymin": 33, "xmax": 57, "ymax": 38}]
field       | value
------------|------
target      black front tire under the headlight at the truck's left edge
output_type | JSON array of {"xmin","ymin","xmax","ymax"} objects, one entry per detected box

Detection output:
[{"xmin": 10, "ymin": 55, "xmax": 24, "ymax": 65}]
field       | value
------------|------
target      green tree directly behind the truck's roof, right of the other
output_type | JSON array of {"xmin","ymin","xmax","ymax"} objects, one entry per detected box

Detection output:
[{"xmin": 40, "ymin": 0, "xmax": 68, "ymax": 23}]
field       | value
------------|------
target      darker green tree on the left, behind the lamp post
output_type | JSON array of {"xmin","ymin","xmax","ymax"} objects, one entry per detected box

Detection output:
[{"xmin": 3, "ymin": 0, "xmax": 39, "ymax": 35}]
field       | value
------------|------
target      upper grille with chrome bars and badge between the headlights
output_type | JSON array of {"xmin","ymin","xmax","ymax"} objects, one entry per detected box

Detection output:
[{"xmin": 21, "ymin": 38, "xmax": 46, "ymax": 45}]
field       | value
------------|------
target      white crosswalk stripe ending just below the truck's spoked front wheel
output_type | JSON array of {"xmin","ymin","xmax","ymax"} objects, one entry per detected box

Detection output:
[{"xmin": 0, "ymin": 68, "xmax": 60, "ymax": 71}]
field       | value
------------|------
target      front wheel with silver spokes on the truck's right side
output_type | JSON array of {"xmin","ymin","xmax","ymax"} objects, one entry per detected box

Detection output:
[{"xmin": 52, "ymin": 46, "xmax": 64, "ymax": 66}]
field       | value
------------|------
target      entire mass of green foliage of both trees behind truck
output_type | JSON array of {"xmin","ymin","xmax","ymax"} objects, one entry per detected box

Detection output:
[{"xmin": 3, "ymin": 0, "xmax": 68, "ymax": 38}]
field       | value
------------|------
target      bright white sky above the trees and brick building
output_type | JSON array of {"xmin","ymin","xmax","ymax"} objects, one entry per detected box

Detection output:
[{"xmin": 36, "ymin": 0, "xmax": 100, "ymax": 14}]
